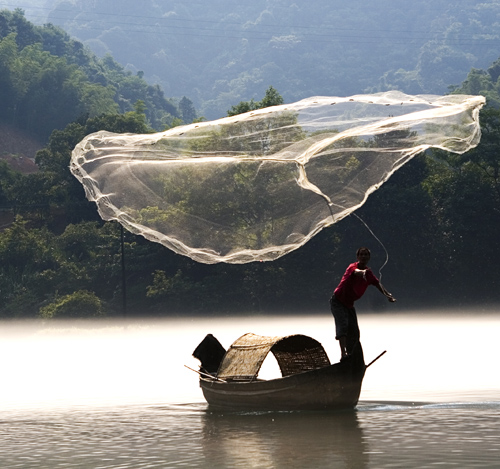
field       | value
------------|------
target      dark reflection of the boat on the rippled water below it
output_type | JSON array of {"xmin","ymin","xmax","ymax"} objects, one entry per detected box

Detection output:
[{"xmin": 202, "ymin": 411, "xmax": 368, "ymax": 469}]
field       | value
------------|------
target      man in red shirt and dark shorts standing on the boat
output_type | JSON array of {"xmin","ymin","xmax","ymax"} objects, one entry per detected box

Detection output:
[{"xmin": 330, "ymin": 248, "xmax": 396, "ymax": 360}]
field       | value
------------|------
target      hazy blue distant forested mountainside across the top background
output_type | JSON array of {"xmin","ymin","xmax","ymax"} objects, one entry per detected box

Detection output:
[{"xmin": 19, "ymin": 0, "xmax": 500, "ymax": 119}]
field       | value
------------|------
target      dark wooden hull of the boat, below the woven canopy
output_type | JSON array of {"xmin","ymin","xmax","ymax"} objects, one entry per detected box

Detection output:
[{"xmin": 200, "ymin": 344, "xmax": 366, "ymax": 410}]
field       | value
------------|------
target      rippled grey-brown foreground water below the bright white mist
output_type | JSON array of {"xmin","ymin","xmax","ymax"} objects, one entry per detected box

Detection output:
[{"xmin": 0, "ymin": 402, "xmax": 500, "ymax": 469}]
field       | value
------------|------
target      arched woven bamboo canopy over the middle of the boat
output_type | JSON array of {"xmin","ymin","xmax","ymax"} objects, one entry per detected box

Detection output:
[{"xmin": 217, "ymin": 333, "xmax": 330, "ymax": 380}]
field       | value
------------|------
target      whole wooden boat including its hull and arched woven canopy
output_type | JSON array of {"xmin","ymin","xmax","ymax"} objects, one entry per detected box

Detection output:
[{"xmin": 193, "ymin": 334, "xmax": 372, "ymax": 410}]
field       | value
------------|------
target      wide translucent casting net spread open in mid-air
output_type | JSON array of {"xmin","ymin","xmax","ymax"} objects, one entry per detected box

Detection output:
[{"xmin": 71, "ymin": 91, "xmax": 484, "ymax": 263}]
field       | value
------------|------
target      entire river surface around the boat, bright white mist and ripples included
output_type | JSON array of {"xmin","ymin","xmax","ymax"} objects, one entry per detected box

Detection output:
[{"xmin": 0, "ymin": 309, "xmax": 500, "ymax": 469}]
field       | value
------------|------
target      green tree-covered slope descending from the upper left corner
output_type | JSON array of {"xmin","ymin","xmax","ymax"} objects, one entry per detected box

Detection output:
[{"xmin": 0, "ymin": 10, "xmax": 191, "ymax": 141}]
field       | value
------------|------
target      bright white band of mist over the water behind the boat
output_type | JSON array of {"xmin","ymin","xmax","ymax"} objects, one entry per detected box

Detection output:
[{"xmin": 0, "ymin": 310, "xmax": 500, "ymax": 409}]
